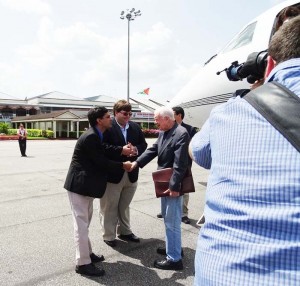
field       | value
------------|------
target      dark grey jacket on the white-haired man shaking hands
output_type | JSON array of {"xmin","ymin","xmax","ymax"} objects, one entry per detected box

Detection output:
[{"xmin": 137, "ymin": 123, "xmax": 190, "ymax": 192}]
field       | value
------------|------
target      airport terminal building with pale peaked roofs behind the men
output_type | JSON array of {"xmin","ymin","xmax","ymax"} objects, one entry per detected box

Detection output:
[{"xmin": 0, "ymin": 91, "xmax": 160, "ymax": 138}]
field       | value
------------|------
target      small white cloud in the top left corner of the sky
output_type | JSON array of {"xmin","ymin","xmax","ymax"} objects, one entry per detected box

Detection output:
[{"xmin": 0, "ymin": 0, "xmax": 51, "ymax": 15}]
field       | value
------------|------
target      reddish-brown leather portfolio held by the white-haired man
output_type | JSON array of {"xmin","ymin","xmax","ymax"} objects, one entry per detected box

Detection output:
[{"xmin": 152, "ymin": 168, "xmax": 195, "ymax": 198}]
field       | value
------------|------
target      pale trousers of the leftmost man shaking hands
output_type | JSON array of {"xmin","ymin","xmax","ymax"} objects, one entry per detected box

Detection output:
[{"xmin": 68, "ymin": 192, "xmax": 94, "ymax": 265}]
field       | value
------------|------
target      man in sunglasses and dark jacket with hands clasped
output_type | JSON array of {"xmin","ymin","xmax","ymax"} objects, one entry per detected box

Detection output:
[{"xmin": 100, "ymin": 100, "xmax": 147, "ymax": 247}]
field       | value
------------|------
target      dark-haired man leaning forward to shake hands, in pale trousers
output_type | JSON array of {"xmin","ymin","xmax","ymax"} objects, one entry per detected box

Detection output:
[{"xmin": 64, "ymin": 107, "xmax": 130, "ymax": 276}]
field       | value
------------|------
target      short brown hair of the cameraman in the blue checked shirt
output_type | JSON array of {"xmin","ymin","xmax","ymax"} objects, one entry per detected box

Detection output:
[{"xmin": 268, "ymin": 15, "xmax": 300, "ymax": 64}]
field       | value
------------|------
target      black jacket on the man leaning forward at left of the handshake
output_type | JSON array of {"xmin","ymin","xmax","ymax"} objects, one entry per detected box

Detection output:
[{"xmin": 64, "ymin": 128, "xmax": 123, "ymax": 198}]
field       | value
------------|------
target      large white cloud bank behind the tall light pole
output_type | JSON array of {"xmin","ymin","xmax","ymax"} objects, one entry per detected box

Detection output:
[{"xmin": 5, "ymin": 16, "xmax": 198, "ymax": 100}]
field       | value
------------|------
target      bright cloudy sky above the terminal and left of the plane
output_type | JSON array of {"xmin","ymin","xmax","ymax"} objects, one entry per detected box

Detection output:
[{"xmin": 0, "ymin": 0, "xmax": 283, "ymax": 102}]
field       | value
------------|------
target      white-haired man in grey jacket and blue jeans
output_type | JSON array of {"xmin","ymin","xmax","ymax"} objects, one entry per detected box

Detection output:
[{"xmin": 131, "ymin": 107, "xmax": 190, "ymax": 270}]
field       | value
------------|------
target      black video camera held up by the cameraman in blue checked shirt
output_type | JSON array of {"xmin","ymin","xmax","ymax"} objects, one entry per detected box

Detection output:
[{"xmin": 217, "ymin": 51, "xmax": 268, "ymax": 84}]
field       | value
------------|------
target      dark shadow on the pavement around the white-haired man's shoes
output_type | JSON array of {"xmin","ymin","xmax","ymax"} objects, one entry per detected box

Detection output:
[{"xmin": 87, "ymin": 239, "xmax": 195, "ymax": 286}]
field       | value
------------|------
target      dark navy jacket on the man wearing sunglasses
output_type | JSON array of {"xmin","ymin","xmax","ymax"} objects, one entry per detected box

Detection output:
[{"xmin": 103, "ymin": 119, "xmax": 147, "ymax": 184}]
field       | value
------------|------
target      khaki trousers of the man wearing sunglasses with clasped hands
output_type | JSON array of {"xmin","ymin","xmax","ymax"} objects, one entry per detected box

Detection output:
[{"xmin": 100, "ymin": 172, "xmax": 137, "ymax": 240}]
